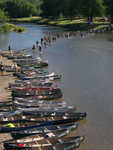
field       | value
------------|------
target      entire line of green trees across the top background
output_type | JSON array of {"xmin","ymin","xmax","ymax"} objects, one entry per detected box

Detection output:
[{"xmin": 0, "ymin": 0, "xmax": 113, "ymax": 21}]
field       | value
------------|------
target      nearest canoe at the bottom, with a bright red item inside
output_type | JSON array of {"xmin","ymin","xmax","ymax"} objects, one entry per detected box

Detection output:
[{"xmin": 4, "ymin": 135, "xmax": 84, "ymax": 150}]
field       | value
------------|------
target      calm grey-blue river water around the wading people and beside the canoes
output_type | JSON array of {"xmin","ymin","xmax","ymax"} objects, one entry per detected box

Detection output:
[{"xmin": 0, "ymin": 24, "xmax": 113, "ymax": 150}]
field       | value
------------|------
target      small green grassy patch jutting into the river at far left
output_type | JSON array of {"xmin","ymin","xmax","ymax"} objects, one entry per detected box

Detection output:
[{"xmin": 0, "ymin": 23, "xmax": 26, "ymax": 32}]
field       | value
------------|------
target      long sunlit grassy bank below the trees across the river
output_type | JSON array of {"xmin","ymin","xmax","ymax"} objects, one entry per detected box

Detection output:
[{"xmin": 11, "ymin": 17, "xmax": 109, "ymax": 30}]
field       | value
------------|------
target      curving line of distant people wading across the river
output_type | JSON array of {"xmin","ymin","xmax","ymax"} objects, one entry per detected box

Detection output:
[{"xmin": 32, "ymin": 29, "xmax": 98, "ymax": 55}]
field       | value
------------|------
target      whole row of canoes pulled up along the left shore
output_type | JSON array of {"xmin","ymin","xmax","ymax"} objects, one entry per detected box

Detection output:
[{"xmin": 0, "ymin": 49, "xmax": 87, "ymax": 150}]
